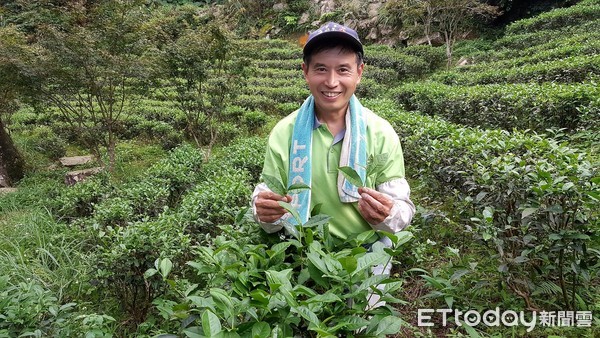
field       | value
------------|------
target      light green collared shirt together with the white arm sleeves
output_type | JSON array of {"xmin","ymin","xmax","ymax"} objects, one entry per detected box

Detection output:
[{"xmin": 252, "ymin": 109, "xmax": 415, "ymax": 239}]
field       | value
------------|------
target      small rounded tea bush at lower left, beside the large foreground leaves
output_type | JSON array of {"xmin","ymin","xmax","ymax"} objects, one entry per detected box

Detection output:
[{"xmin": 94, "ymin": 215, "xmax": 192, "ymax": 327}]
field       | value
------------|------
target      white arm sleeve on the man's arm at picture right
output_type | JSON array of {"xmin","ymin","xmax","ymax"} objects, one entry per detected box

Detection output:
[{"xmin": 371, "ymin": 178, "xmax": 415, "ymax": 233}]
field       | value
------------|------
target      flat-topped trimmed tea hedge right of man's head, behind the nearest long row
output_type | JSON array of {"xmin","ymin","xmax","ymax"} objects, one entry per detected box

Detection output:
[{"xmin": 392, "ymin": 82, "xmax": 600, "ymax": 132}]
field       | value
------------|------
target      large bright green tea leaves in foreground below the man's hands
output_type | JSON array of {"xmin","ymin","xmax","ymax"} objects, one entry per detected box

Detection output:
[{"xmin": 152, "ymin": 216, "xmax": 410, "ymax": 337}]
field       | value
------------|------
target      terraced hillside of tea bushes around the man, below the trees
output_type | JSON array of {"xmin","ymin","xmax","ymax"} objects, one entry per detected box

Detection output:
[{"xmin": 0, "ymin": 0, "xmax": 600, "ymax": 337}]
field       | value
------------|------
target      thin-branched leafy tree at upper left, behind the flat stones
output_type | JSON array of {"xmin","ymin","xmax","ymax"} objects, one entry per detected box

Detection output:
[{"xmin": 5, "ymin": 0, "xmax": 155, "ymax": 170}]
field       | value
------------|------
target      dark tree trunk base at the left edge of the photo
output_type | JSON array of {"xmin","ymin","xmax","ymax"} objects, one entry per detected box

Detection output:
[{"xmin": 0, "ymin": 120, "xmax": 25, "ymax": 186}]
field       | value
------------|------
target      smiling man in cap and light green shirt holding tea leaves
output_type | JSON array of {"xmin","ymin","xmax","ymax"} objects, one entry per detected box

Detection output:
[{"xmin": 252, "ymin": 22, "xmax": 415, "ymax": 306}]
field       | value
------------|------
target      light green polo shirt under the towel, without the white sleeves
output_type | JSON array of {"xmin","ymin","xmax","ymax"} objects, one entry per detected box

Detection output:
[{"xmin": 263, "ymin": 108, "xmax": 404, "ymax": 239}]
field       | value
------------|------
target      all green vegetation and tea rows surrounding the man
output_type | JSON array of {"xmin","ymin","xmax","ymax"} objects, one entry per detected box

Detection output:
[{"xmin": 0, "ymin": 0, "xmax": 600, "ymax": 337}]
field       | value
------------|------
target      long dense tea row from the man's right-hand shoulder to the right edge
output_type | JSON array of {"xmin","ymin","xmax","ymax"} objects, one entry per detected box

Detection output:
[{"xmin": 370, "ymin": 97, "xmax": 600, "ymax": 309}]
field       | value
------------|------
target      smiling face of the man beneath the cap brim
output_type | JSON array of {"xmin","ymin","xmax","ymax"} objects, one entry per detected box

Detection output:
[{"xmin": 302, "ymin": 47, "xmax": 364, "ymax": 117}]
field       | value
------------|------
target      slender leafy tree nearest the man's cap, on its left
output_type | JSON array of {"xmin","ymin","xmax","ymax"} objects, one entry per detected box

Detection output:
[{"xmin": 155, "ymin": 8, "xmax": 248, "ymax": 158}]
